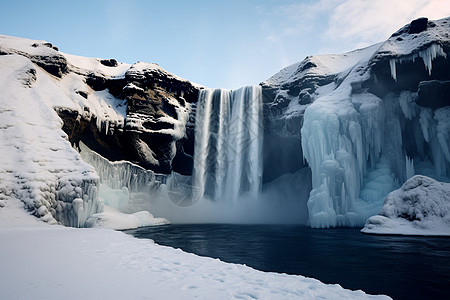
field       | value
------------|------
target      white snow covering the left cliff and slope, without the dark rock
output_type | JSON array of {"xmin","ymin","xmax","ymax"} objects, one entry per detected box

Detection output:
[{"xmin": 0, "ymin": 35, "xmax": 173, "ymax": 229}]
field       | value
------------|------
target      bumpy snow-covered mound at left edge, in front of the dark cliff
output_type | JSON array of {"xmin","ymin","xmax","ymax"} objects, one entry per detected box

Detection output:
[{"xmin": 0, "ymin": 55, "xmax": 102, "ymax": 226}]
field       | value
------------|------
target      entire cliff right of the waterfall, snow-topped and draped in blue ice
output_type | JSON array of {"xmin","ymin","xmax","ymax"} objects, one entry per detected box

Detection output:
[{"xmin": 262, "ymin": 18, "xmax": 450, "ymax": 227}]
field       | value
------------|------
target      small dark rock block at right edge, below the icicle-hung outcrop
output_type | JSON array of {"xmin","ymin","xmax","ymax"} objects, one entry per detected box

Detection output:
[{"xmin": 416, "ymin": 80, "xmax": 450, "ymax": 109}]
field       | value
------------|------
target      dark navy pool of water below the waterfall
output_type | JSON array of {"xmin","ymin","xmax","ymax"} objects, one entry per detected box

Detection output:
[{"xmin": 126, "ymin": 224, "xmax": 450, "ymax": 299}]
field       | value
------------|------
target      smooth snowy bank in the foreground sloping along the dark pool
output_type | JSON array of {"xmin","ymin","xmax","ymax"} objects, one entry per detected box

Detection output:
[{"xmin": 0, "ymin": 199, "xmax": 390, "ymax": 300}]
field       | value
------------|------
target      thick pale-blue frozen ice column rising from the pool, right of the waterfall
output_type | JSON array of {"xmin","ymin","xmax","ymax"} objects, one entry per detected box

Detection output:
[{"xmin": 302, "ymin": 87, "xmax": 392, "ymax": 227}]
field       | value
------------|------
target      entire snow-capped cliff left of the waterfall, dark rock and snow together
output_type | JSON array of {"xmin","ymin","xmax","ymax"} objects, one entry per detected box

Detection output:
[{"xmin": 0, "ymin": 36, "xmax": 200, "ymax": 227}]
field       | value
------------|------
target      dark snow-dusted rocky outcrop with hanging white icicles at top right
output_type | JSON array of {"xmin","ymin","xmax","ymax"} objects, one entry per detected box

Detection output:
[{"xmin": 363, "ymin": 18, "xmax": 450, "ymax": 98}]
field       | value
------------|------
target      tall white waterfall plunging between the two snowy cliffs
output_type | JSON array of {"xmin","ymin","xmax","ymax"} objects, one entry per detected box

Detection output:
[{"xmin": 193, "ymin": 86, "xmax": 263, "ymax": 201}]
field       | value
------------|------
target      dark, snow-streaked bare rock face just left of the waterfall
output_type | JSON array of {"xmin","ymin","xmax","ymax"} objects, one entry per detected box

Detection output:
[{"xmin": 58, "ymin": 60, "xmax": 202, "ymax": 175}]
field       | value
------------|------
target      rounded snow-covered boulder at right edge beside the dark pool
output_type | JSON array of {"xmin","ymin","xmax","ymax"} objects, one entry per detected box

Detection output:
[{"xmin": 361, "ymin": 175, "xmax": 450, "ymax": 236}]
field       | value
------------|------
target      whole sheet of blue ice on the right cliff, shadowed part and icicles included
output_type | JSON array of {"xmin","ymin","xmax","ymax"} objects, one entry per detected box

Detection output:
[{"xmin": 302, "ymin": 39, "xmax": 450, "ymax": 228}]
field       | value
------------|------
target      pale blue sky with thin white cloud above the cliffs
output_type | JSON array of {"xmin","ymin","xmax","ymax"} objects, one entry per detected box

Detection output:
[{"xmin": 0, "ymin": 0, "xmax": 450, "ymax": 89}]
